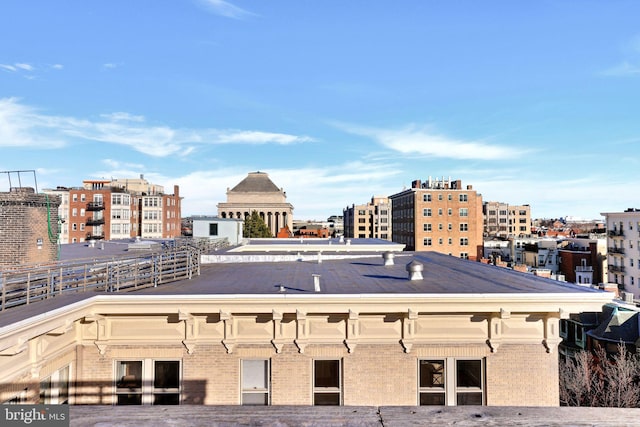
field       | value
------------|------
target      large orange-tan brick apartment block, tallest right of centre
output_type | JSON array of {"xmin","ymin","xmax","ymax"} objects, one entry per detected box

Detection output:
[{"xmin": 389, "ymin": 177, "xmax": 484, "ymax": 260}]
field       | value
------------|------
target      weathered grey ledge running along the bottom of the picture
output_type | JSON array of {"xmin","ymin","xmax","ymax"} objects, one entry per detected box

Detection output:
[{"xmin": 69, "ymin": 405, "xmax": 638, "ymax": 427}]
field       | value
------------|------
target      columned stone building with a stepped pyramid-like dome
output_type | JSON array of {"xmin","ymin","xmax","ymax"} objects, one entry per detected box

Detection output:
[{"xmin": 218, "ymin": 171, "xmax": 293, "ymax": 236}]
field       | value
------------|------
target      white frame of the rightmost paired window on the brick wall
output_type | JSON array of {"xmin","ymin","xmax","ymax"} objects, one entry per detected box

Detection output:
[{"xmin": 417, "ymin": 357, "xmax": 486, "ymax": 406}]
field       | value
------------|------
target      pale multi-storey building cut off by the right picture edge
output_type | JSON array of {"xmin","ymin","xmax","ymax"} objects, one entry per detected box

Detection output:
[{"xmin": 600, "ymin": 208, "xmax": 640, "ymax": 299}]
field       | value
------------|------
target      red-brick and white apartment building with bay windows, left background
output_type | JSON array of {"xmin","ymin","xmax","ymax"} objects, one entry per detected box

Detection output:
[{"xmin": 44, "ymin": 176, "xmax": 181, "ymax": 243}]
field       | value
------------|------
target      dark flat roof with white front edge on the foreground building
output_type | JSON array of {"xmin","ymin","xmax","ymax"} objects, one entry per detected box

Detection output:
[{"xmin": 0, "ymin": 244, "xmax": 602, "ymax": 327}]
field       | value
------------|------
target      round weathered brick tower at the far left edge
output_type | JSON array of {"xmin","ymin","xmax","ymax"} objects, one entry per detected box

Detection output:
[{"xmin": 0, "ymin": 187, "xmax": 60, "ymax": 266}]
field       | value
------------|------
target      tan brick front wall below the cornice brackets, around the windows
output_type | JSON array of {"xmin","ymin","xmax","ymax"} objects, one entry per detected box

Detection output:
[{"xmin": 70, "ymin": 343, "xmax": 559, "ymax": 406}]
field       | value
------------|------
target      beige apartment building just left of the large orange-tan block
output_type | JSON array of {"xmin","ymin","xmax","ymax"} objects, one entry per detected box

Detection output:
[{"xmin": 343, "ymin": 196, "xmax": 393, "ymax": 241}]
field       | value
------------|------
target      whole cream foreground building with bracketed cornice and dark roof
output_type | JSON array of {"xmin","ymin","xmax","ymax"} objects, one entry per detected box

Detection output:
[{"xmin": 0, "ymin": 251, "xmax": 613, "ymax": 406}]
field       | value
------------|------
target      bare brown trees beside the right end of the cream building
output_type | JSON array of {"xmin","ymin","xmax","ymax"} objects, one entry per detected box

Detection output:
[{"xmin": 560, "ymin": 344, "xmax": 640, "ymax": 408}]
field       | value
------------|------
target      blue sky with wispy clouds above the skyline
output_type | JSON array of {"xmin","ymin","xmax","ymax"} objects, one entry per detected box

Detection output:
[{"xmin": 0, "ymin": 0, "xmax": 640, "ymax": 219}]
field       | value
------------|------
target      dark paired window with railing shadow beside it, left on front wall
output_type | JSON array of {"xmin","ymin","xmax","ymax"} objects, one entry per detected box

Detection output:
[{"xmin": 116, "ymin": 359, "xmax": 180, "ymax": 405}]
